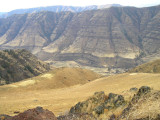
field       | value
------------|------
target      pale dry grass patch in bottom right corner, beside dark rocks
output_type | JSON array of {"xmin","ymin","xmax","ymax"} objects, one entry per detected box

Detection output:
[{"xmin": 126, "ymin": 90, "xmax": 160, "ymax": 120}]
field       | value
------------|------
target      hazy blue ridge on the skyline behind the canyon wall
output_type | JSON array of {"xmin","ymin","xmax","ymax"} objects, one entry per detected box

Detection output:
[{"xmin": 0, "ymin": 4, "xmax": 121, "ymax": 18}]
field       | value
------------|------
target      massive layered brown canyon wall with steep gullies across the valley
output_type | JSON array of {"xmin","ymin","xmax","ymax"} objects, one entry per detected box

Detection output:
[{"xmin": 0, "ymin": 6, "xmax": 160, "ymax": 68}]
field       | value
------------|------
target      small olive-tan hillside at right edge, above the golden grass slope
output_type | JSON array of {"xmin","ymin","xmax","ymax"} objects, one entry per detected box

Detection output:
[{"xmin": 129, "ymin": 59, "xmax": 160, "ymax": 73}]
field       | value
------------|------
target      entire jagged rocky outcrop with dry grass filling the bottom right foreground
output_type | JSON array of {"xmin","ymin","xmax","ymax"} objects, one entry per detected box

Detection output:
[{"xmin": 69, "ymin": 86, "xmax": 160, "ymax": 120}]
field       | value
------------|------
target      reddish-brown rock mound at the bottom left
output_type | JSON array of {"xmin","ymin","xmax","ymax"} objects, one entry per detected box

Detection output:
[{"xmin": 6, "ymin": 107, "xmax": 57, "ymax": 120}]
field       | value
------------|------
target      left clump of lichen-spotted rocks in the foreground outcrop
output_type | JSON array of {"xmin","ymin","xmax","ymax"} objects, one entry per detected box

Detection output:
[{"xmin": 69, "ymin": 91, "xmax": 126, "ymax": 116}]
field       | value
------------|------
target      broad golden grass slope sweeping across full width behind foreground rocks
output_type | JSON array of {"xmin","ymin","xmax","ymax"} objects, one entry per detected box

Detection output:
[{"xmin": 0, "ymin": 69, "xmax": 160, "ymax": 115}]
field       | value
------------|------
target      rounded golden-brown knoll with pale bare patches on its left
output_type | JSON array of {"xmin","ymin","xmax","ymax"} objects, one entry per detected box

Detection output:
[{"xmin": 1, "ymin": 68, "xmax": 101, "ymax": 90}]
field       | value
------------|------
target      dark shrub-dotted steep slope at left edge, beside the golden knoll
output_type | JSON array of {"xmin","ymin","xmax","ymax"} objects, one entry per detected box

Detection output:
[{"xmin": 0, "ymin": 49, "xmax": 50, "ymax": 85}]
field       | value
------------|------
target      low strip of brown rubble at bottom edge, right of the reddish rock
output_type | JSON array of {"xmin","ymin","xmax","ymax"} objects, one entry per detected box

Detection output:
[{"xmin": 57, "ymin": 113, "xmax": 97, "ymax": 120}]
